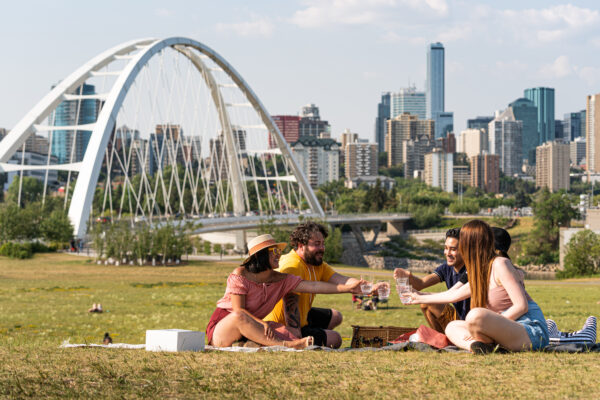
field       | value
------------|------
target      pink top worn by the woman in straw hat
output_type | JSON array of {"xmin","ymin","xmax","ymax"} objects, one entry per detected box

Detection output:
[{"xmin": 217, "ymin": 274, "xmax": 302, "ymax": 319}]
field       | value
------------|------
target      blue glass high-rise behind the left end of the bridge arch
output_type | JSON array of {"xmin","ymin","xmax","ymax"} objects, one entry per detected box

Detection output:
[{"xmin": 50, "ymin": 83, "xmax": 101, "ymax": 164}]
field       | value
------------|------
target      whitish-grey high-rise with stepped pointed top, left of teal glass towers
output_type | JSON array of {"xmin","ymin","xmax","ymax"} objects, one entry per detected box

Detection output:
[{"xmin": 488, "ymin": 107, "xmax": 523, "ymax": 176}]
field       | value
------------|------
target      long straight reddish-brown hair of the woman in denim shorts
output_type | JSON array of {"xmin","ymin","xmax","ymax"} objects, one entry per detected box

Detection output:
[{"xmin": 458, "ymin": 219, "xmax": 496, "ymax": 308}]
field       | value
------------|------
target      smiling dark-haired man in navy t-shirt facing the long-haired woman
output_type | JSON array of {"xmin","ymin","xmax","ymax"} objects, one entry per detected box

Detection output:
[{"xmin": 394, "ymin": 228, "xmax": 470, "ymax": 333}]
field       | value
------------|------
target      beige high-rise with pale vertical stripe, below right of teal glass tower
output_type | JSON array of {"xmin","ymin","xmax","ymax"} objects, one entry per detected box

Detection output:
[{"xmin": 535, "ymin": 141, "xmax": 571, "ymax": 192}]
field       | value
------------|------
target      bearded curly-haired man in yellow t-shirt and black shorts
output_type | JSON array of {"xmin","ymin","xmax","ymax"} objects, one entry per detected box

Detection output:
[{"xmin": 264, "ymin": 222, "xmax": 356, "ymax": 348}]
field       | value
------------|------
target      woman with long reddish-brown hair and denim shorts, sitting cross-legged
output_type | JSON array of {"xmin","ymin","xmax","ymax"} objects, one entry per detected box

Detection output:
[{"xmin": 411, "ymin": 220, "xmax": 549, "ymax": 353}]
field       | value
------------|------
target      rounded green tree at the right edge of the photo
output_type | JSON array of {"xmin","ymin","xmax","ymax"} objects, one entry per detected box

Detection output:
[{"xmin": 557, "ymin": 229, "xmax": 600, "ymax": 278}]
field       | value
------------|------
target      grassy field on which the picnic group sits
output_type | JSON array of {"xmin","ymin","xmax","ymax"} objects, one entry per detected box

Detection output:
[{"xmin": 0, "ymin": 254, "xmax": 600, "ymax": 399}]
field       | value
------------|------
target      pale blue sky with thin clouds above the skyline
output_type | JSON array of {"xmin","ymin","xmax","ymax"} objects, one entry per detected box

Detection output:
[{"xmin": 0, "ymin": 0, "xmax": 600, "ymax": 139}]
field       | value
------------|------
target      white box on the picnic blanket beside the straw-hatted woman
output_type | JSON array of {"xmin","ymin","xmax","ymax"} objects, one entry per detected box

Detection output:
[{"xmin": 146, "ymin": 329, "xmax": 204, "ymax": 351}]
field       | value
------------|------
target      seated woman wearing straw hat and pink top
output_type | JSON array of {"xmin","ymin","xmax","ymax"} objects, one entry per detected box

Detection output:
[{"xmin": 206, "ymin": 234, "xmax": 362, "ymax": 349}]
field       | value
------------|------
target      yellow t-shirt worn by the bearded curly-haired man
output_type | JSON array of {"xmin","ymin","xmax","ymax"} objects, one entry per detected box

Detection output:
[{"xmin": 263, "ymin": 250, "xmax": 335, "ymax": 327}]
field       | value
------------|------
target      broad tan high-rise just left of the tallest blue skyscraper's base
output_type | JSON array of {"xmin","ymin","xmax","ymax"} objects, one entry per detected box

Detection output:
[{"xmin": 385, "ymin": 113, "xmax": 433, "ymax": 167}]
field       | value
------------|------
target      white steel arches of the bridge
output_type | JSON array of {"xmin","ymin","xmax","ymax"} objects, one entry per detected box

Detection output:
[{"xmin": 0, "ymin": 37, "xmax": 324, "ymax": 237}]
